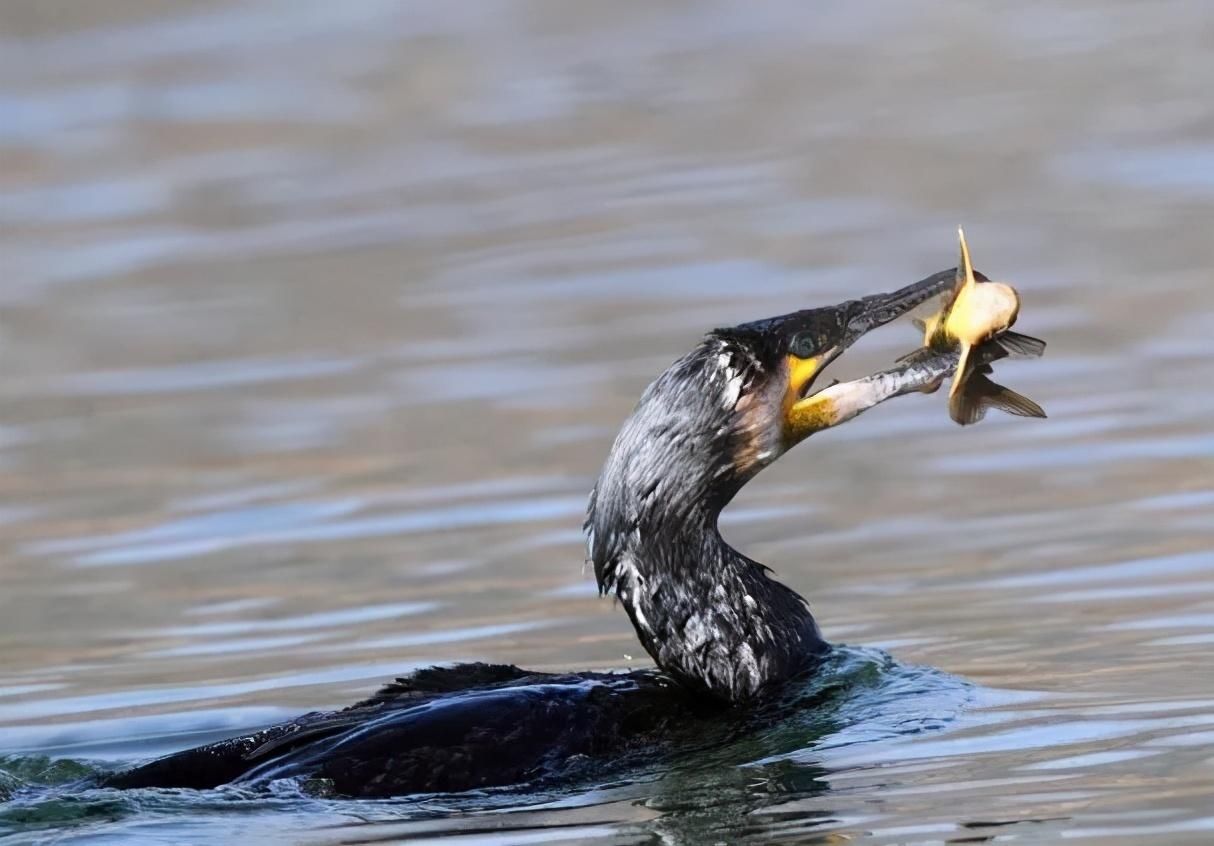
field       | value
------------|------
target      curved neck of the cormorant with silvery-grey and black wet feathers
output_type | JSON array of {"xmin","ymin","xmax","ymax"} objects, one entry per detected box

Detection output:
[{"xmin": 586, "ymin": 335, "xmax": 828, "ymax": 702}]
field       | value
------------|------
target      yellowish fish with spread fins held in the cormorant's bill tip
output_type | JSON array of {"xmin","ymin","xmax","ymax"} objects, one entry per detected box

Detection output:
[{"xmin": 898, "ymin": 227, "xmax": 1045, "ymax": 426}]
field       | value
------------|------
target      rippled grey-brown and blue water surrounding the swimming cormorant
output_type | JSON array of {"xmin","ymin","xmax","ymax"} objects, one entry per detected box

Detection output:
[{"xmin": 0, "ymin": 0, "xmax": 1214, "ymax": 846}]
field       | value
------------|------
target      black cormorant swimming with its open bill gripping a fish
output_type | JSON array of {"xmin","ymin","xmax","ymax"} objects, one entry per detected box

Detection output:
[{"xmin": 103, "ymin": 269, "xmax": 957, "ymax": 796}]
